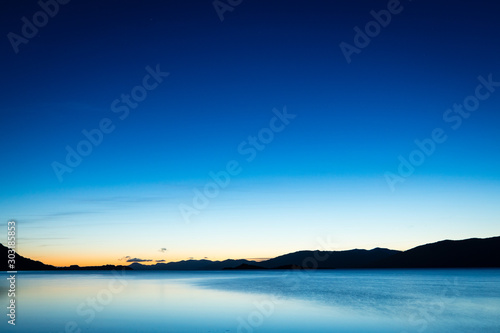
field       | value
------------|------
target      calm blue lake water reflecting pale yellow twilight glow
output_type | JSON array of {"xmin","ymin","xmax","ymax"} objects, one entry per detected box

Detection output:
[{"xmin": 0, "ymin": 269, "xmax": 500, "ymax": 333}]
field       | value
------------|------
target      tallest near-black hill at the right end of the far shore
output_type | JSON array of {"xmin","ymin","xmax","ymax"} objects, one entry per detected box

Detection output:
[{"xmin": 374, "ymin": 237, "xmax": 500, "ymax": 268}]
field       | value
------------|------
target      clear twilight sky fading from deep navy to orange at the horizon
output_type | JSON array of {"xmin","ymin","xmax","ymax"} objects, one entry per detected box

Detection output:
[{"xmin": 0, "ymin": 0, "xmax": 500, "ymax": 266}]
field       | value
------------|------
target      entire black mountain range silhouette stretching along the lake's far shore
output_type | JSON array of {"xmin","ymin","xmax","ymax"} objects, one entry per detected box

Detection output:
[{"xmin": 0, "ymin": 236, "xmax": 500, "ymax": 271}]
